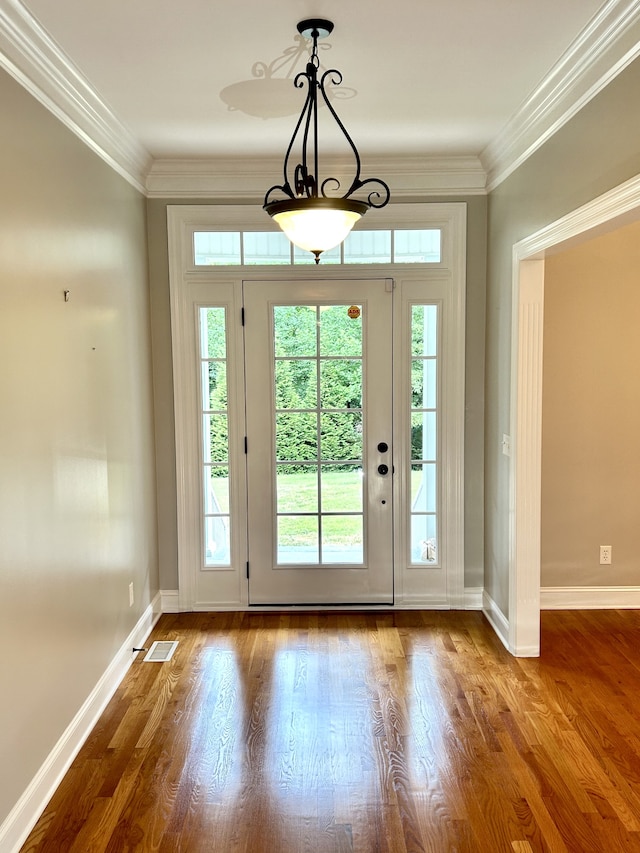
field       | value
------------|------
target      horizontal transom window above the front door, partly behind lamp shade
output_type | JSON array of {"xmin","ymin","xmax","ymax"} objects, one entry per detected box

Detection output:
[{"xmin": 193, "ymin": 228, "xmax": 442, "ymax": 267}]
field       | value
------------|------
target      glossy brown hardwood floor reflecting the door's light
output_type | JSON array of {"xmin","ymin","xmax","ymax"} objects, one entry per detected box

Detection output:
[{"xmin": 18, "ymin": 611, "xmax": 640, "ymax": 853}]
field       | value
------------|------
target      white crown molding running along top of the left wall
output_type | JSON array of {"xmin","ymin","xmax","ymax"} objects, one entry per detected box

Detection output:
[{"xmin": 0, "ymin": 0, "xmax": 151, "ymax": 193}]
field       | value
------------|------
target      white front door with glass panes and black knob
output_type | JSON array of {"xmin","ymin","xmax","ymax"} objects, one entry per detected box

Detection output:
[{"xmin": 243, "ymin": 279, "xmax": 394, "ymax": 605}]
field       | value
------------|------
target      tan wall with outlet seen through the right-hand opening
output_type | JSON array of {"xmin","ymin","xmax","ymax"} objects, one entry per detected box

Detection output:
[{"xmin": 540, "ymin": 222, "xmax": 640, "ymax": 587}]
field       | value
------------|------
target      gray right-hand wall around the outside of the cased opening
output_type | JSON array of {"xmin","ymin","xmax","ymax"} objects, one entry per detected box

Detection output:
[{"xmin": 485, "ymin": 56, "xmax": 640, "ymax": 614}]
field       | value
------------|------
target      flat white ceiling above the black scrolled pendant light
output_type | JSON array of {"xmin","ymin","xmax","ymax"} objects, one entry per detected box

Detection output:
[{"xmin": 18, "ymin": 0, "xmax": 612, "ymax": 163}]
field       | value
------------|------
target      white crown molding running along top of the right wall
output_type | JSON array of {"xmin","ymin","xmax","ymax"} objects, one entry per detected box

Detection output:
[{"xmin": 480, "ymin": 0, "xmax": 640, "ymax": 192}]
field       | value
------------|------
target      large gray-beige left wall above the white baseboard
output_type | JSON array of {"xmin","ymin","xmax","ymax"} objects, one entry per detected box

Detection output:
[{"xmin": 0, "ymin": 71, "xmax": 158, "ymax": 824}]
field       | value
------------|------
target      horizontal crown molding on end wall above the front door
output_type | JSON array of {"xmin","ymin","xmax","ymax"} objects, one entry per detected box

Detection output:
[{"xmin": 146, "ymin": 157, "xmax": 486, "ymax": 202}]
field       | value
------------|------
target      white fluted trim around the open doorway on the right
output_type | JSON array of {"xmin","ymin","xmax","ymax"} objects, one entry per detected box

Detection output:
[{"xmin": 510, "ymin": 170, "xmax": 640, "ymax": 657}]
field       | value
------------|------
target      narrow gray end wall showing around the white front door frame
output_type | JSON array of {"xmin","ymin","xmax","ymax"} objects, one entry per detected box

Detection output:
[{"xmin": 147, "ymin": 196, "xmax": 487, "ymax": 590}]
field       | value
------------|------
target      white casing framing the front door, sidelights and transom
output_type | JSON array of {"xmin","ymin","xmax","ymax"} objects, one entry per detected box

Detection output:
[{"xmin": 163, "ymin": 202, "xmax": 464, "ymax": 611}]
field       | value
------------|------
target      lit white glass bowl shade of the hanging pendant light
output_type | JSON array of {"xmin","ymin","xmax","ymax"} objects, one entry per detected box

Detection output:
[{"xmin": 265, "ymin": 197, "xmax": 369, "ymax": 260}]
